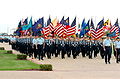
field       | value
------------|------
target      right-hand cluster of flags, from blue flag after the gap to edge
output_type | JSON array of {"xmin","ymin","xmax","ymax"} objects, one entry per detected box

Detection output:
[{"xmin": 80, "ymin": 18, "xmax": 120, "ymax": 40}]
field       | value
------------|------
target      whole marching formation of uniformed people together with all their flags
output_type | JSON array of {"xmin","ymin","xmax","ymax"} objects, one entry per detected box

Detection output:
[{"xmin": 0, "ymin": 16, "xmax": 120, "ymax": 64}]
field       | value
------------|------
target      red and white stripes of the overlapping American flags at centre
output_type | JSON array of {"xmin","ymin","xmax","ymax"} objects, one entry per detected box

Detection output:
[{"xmin": 42, "ymin": 23, "xmax": 76, "ymax": 37}]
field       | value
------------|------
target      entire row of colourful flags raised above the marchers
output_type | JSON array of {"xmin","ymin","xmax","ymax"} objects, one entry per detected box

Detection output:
[{"xmin": 14, "ymin": 16, "xmax": 120, "ymax": 39}]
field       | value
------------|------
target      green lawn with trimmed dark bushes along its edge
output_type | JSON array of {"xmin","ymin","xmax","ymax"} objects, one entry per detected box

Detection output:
[{"xmin": 0, "ymin": 50, "xmax": 39, "ymax": 71}]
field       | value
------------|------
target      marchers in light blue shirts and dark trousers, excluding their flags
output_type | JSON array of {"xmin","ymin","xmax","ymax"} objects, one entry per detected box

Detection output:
[{"xmin": 0, "ymin": 35, "xmax": 120, "ymax": 64}]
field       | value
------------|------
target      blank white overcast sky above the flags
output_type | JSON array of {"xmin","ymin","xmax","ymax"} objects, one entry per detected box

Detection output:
[{"xmin": 0, "ymin": 0, "xmax": 120, "ymax": 32}]
